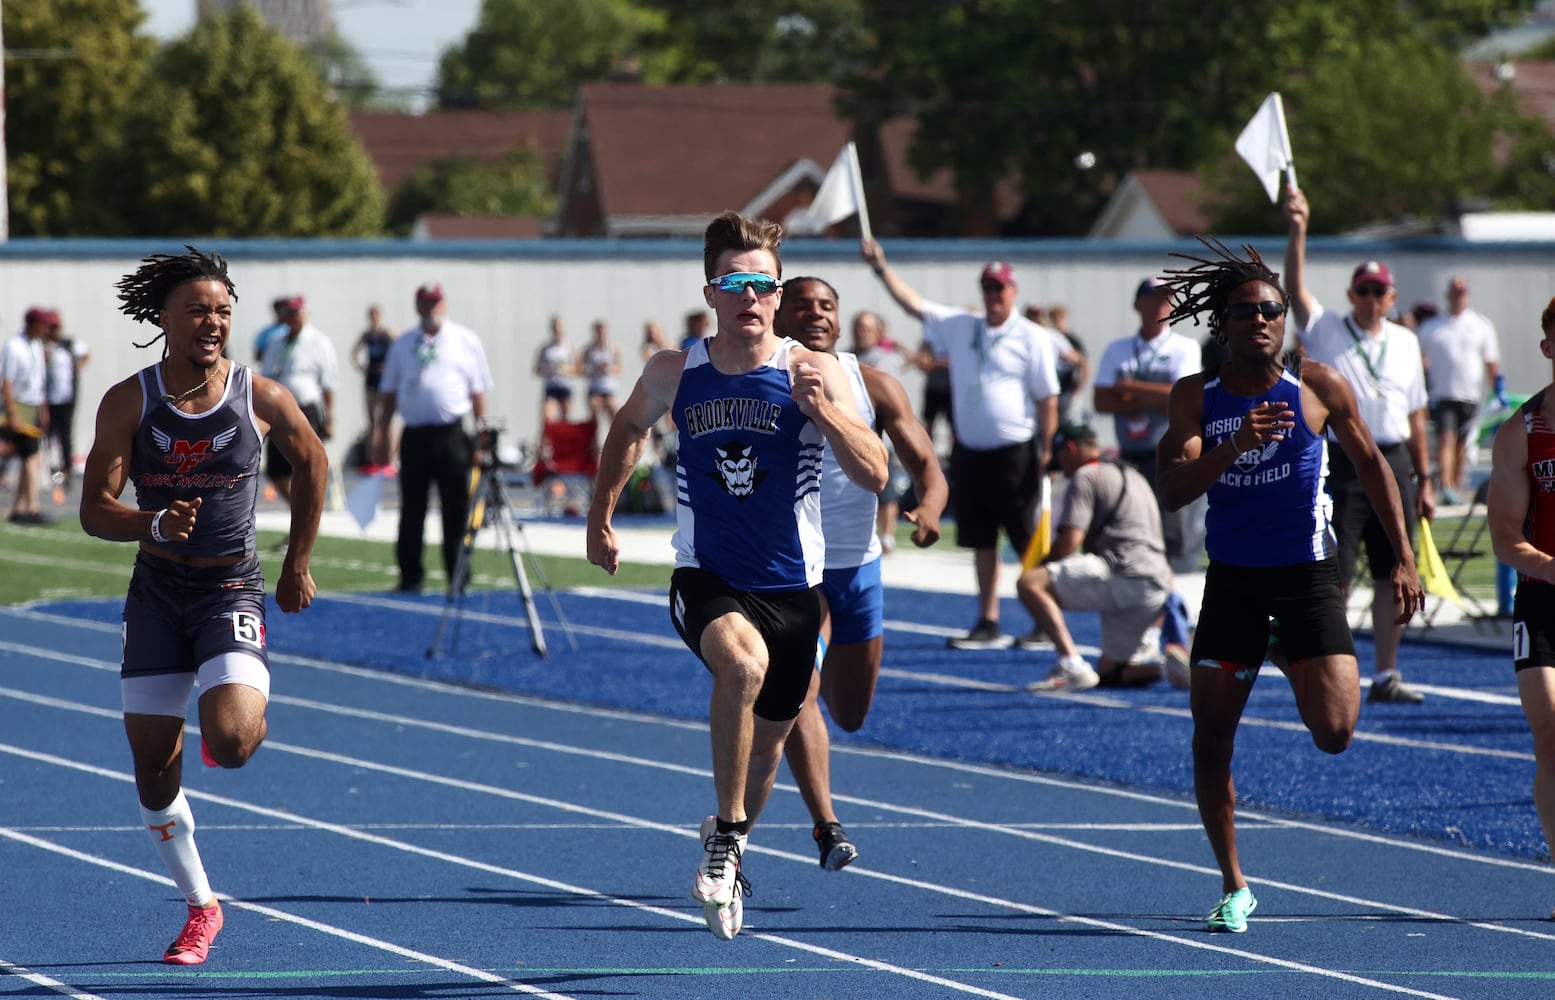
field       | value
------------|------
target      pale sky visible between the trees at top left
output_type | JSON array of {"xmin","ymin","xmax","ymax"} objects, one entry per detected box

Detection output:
[{"xmin": 140, "ymin": 0, "xmax": 480, "ymax": 107}]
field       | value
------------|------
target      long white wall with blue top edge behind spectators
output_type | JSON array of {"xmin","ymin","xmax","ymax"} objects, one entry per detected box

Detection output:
[{"xmin": 12, "ymin": 238, "xmax": 1555, "ymax": 453}]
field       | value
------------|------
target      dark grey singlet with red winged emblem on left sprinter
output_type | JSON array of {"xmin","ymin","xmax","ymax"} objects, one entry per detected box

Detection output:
[{"xmin": 129, "ymin": 362, "xmax": 264, "ymax": 555}]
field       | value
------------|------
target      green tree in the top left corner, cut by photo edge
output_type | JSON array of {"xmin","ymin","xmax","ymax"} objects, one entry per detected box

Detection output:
[{"xmin": 3, "ymin": 0, "xmax": 156, "ymax": 236}]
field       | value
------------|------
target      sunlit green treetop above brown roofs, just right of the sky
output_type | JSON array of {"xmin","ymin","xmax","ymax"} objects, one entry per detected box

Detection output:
[{"xmin": 437, "ymin": 0, "xmax": 664, "ymax": 109}]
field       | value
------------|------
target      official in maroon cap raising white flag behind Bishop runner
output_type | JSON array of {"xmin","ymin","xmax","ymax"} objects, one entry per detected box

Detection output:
[{"xmin": 1284, "ymin": 187, "xmax": 1437, "ymax": 705}]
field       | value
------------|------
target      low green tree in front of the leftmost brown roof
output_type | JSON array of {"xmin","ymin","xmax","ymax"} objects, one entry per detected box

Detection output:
[{"xmin": 387, "ymin": 143, "xmax": 557, "ymax": 235}]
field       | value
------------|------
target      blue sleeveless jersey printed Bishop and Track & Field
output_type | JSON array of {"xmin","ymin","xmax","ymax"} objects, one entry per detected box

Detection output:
[{"xmin": 1204, "ymin": 369, "xmax": 1334, "ymax": 566}]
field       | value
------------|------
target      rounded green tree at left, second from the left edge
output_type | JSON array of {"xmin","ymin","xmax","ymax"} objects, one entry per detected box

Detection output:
[{"xmin": 104, "ymin": 6, "xmax": 383, "ymax": 236}]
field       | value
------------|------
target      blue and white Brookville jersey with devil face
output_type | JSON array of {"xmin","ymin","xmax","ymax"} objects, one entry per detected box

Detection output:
[{"xmin": 670, "ymin": 339, "xmax": 826, "ymax": 591}]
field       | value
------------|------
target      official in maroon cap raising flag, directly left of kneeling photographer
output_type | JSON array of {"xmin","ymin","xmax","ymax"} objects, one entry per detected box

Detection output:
[{"xmin": 858, "ymin": 236, "xmax": 1059, "ymax": 649}]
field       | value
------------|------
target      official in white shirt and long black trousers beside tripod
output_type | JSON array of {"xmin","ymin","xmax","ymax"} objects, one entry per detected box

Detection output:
[{"xmin": 378, "ymin": 285, "xmax": 491, "ymax": 591}]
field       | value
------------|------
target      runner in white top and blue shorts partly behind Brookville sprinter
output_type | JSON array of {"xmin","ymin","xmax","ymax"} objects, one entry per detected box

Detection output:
[{"xmin": 776, "ymin": 277, "xmax": 950, "ymax": 871}]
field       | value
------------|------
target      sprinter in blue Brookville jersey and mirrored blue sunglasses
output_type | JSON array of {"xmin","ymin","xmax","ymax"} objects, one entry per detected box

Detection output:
[{"xmin": 588, "ymin": 212, "xmax": 886, "ymax": 939}]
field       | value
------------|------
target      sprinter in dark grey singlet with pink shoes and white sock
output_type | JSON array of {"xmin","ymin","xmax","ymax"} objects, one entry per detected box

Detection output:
[{"xmin": 81, "ymin": 247, "xmax": 327, "ymax": 966}]
